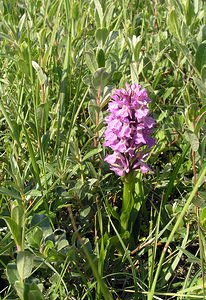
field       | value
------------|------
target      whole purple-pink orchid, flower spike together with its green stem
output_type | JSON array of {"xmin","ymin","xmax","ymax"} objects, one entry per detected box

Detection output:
[{"xmin": 104, "ymin": 83, "xmax": 155, "ymax": 237}]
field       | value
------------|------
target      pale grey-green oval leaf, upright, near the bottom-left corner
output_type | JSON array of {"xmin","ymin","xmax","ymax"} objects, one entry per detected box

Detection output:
[{"xmin": 16, "ymin": 251, "xmax": 34, "ymax": 280}]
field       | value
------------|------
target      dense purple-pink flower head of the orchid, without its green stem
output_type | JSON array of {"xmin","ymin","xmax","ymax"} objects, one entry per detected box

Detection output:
[{"xmin": 104, "ymin": 83, "xmax": 155, "ymax": 176}]
